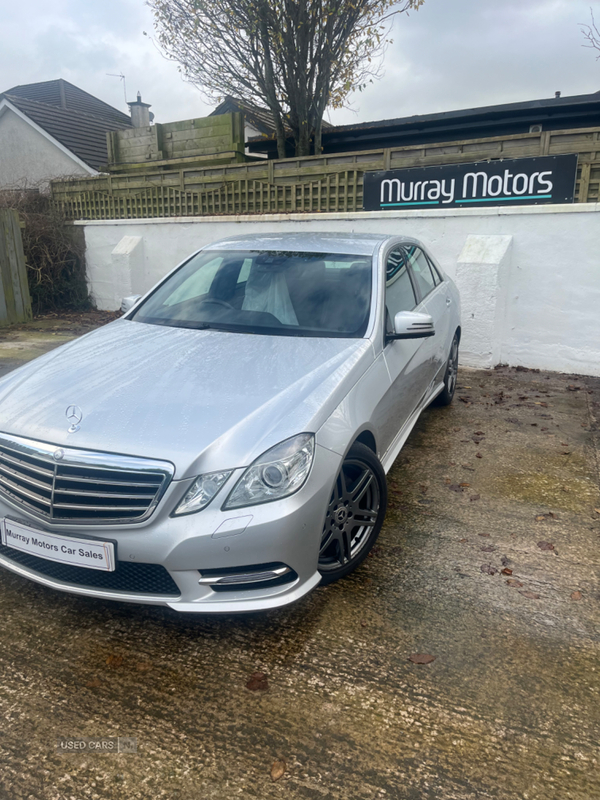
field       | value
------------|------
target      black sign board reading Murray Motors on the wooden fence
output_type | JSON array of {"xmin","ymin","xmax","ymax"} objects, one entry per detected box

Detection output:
[{"xmin": 363, "ymin": 155, "xmax": 577, "ymax": 211}]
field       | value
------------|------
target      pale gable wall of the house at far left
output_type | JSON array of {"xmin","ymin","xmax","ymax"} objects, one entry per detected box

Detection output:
[{"xmin": 0, "ymin": 107, "xmax": 91, "ymax": 191}]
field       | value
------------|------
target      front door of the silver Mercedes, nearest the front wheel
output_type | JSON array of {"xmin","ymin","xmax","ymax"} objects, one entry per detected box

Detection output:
[{"xmin": 376, "ymin": 247, "xmax": 431, "ymax": 453}]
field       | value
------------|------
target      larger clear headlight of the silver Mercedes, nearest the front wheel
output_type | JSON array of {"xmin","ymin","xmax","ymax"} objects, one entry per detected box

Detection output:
[{"xmin": 223, "ymin": 433, "xmax": 315, "ymax": 509}]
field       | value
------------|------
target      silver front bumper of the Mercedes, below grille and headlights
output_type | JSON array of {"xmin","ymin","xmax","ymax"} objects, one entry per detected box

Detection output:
[{"xmin": 0, "ymin": 445, "xmax": 340, "ymax": 613}]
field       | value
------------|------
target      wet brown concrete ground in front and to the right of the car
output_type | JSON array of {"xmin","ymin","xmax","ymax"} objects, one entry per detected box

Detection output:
[{"xmin": 0, "ymin": 320, "xmax": 600, "ymax": 800}]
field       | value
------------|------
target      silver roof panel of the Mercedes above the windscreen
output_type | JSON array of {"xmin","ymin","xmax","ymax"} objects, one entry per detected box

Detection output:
[{"xmin": 205, "ymin": 232, "xmax": 416, "ymax": 256}]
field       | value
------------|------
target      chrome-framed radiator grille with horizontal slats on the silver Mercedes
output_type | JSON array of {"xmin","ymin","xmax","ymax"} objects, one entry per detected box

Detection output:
[{"xmin": 0, "ymin": 434, "xmax": 173, "ymax": 524}]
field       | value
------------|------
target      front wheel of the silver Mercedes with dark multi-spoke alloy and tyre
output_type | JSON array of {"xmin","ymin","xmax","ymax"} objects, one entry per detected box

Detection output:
[{"xmin": 319, "ymin": 443, "xmax": 387, "ymax": 585}]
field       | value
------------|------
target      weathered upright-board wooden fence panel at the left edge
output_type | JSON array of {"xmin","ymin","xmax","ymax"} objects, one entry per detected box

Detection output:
[{"xmin": 0, "ymin": 209, "xmax": 32, "ymax": 325}]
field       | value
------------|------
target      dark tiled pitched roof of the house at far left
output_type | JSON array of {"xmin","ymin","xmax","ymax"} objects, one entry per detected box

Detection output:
[{"xmin": 0, "ymin": 78, "xmax": 131, "ymax": 169}]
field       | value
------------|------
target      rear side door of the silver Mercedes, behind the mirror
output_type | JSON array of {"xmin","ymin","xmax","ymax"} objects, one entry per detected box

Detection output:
[{"xmin": 406, "ymin": 245, "xmax": 450, "ymax": 383}]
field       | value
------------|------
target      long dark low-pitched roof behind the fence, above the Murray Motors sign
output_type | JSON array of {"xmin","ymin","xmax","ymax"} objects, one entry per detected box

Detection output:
[{"xmin": 248, "ymin": 92, "xmax": 600, "ymax": 155}]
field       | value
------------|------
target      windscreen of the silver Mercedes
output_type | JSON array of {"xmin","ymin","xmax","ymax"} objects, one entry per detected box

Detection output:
[{"xmin": 132, "ymin": 250, "xmax": 372, "ymax": 338}]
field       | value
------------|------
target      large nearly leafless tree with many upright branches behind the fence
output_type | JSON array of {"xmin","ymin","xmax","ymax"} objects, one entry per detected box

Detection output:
[{"xmin": 148, "ymin": 0, "xmax": 424, "ymax": 158}]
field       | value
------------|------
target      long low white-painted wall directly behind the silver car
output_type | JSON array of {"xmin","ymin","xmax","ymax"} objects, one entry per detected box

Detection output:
[{"xmin": 74, "ymin": 203, "xmax": 600, "ymax": 375}]
